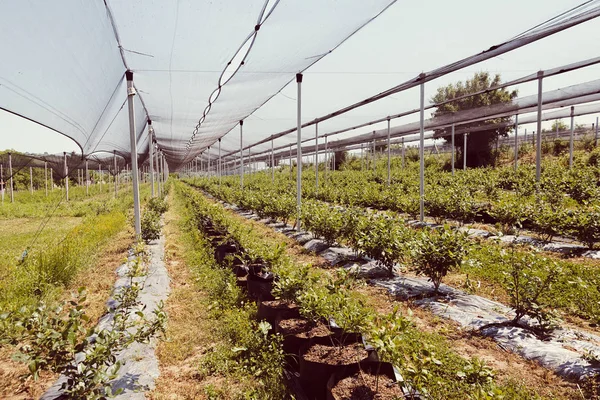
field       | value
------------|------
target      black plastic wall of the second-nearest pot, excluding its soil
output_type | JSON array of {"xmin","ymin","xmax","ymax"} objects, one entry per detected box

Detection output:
[{"xmin": 298, "ymin": 344, "xmax": 367, "ymax": 400}]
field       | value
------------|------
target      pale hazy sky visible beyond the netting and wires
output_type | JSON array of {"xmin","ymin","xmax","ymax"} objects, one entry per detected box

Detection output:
[{"xmin": 0, "ymin": 0, "xmax": 600, "ymax": 159}]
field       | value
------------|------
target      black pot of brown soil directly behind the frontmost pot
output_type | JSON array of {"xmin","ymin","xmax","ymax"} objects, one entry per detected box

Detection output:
[{"xmin": 299, "ymin": 343, "xmax": 369, "ymax": 399}]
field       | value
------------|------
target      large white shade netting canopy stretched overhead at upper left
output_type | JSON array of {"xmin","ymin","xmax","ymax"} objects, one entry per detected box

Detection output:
[{"xmin": 0, "ymin": 0, "xmax": 394, "ymax": 169}]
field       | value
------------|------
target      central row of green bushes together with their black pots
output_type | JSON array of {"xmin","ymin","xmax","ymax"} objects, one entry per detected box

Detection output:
[{"xmin": 178, "ymin": 184, "xmax": 536, "ymax": 399}]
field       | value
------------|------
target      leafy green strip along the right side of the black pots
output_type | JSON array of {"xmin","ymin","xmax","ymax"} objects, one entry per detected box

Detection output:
[{"xmin": 179, "ymin": 184, "xmax": 539, "ymax": 400}]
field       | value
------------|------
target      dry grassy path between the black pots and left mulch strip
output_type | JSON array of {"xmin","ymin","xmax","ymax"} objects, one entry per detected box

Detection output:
[{"xmin": 152, "ymin": 185, "xmax": 285, "ymax": 400}]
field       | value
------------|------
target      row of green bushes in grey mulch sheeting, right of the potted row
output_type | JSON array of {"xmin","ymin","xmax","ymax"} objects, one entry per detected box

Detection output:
[{"xmin": 190, "ymin": 181, "xmax": 600, "ymax": 328}]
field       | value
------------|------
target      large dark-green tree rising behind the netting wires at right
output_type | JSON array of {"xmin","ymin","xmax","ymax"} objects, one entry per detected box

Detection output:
[{"xmin": 431, "ymin": 72, "xmax": 517, "ymax": 167}]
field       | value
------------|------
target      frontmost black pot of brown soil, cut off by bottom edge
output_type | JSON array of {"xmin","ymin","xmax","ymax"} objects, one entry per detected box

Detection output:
[{"xmin": 327, "ymin": 362, "xmax": 405, "ymax": 400}]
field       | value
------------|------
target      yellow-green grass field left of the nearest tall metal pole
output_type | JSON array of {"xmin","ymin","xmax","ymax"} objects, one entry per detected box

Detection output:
[{"xmin": 0, "ymin": 185, "xmax": 149, "ymax": 311}]
